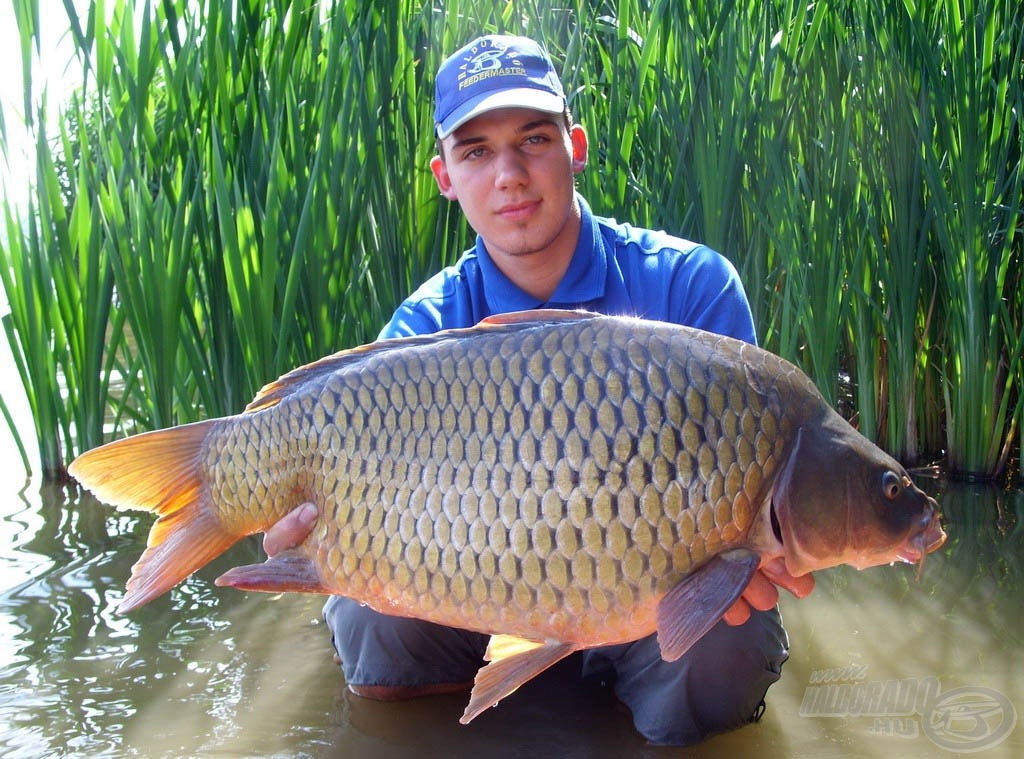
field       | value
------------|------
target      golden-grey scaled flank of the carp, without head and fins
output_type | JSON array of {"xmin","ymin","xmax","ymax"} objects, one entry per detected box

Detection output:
[{"xmin": 197, "ymin": 311, "xmax": 784, "ymax": 640}]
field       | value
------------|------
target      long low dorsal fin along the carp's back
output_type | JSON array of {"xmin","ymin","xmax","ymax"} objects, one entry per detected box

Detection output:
[{"xmin": 245, "ymin": 308, "xmax": 599, "ymax": 413}]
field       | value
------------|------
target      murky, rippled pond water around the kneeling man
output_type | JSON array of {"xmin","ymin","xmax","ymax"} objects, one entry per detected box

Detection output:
[{"xmin": 0, "ymin": 473, "xmax": 1024, "ymax": 757}]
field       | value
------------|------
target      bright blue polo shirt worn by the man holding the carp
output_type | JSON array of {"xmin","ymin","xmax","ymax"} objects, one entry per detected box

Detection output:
[{"xmin": 380, "ymin": 196, "xmax": 757, "ymax": 343}]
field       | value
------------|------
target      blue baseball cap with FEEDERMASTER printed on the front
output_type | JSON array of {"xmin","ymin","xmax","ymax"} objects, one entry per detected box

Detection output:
[{"xmin": 434, "ymin": 35, "xmax": 565, "ymax": 139}]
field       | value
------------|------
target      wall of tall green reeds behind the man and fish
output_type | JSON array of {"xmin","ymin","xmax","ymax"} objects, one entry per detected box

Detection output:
[{"xmin": 0, "ymin": 0, "xmax": 1024, "ymax": 475}]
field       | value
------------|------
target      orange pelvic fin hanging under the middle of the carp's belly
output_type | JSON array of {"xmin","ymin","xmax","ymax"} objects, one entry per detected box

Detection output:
[{"xmin": 459, "ymin": 635, "xmax": 577, "ymax": 725}]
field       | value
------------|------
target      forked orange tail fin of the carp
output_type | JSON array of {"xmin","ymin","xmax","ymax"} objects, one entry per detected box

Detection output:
[{"xmin": 68, "ymin": 420, "xmax": 243, "ymax": 614}]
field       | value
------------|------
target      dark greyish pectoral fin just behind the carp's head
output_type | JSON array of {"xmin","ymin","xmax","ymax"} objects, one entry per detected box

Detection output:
[{"xmin": 657, "ymin": 549, "xmax": 761, "ymax": 662}]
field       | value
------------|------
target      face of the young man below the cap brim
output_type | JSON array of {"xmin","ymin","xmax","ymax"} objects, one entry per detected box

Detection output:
[{"xmin": 430, "ymin": 109, "xmax": 587, "ymax": 266}]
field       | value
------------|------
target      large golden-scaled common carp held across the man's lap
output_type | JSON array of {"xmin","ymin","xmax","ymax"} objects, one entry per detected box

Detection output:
[{"xmin": 70, "ymin": 311, "xmax": 945, "ymax": 722}]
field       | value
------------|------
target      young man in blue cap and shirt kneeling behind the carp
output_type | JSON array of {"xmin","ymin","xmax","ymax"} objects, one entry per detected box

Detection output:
[{"xmin": 264, "ymin": 36, "xmax": 813, "ymax": 745}]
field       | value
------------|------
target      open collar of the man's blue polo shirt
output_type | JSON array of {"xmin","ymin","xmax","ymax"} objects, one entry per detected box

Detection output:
[{"xmin": 476, "ymin": 194, "xmax": 608, "ymax": 313}]
